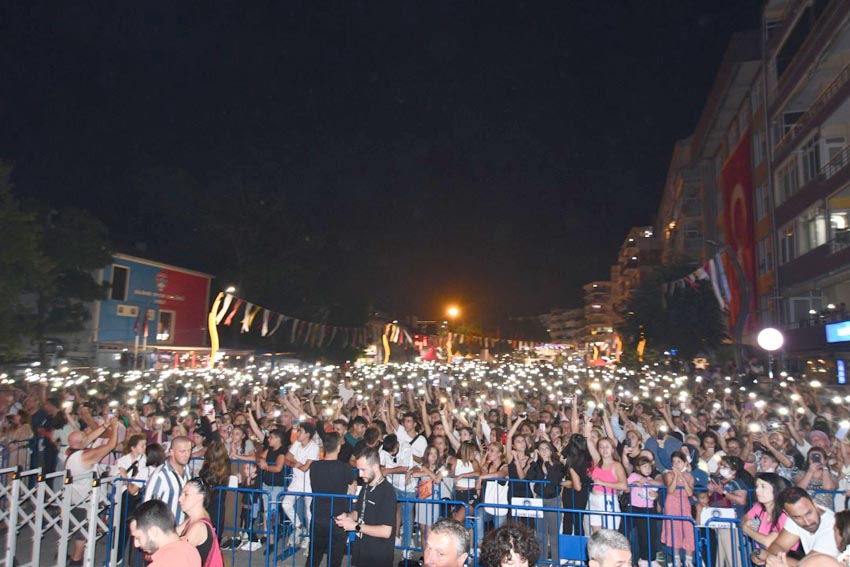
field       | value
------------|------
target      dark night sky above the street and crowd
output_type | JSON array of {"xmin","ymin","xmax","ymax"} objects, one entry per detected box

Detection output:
[{"xmin": 0, "ymin": 0, "xmax": 761, "ymax": 324}]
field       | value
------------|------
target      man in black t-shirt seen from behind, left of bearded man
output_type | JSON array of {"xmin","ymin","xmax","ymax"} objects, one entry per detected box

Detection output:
[{"xmin": 307, "ymin": 433, "xmax": 357, "ymax": 567}]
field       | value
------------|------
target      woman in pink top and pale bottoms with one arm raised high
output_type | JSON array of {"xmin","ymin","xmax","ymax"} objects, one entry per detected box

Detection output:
[{"xmin": 584, "ymin": 421, "xmax": 629, "ymax": 532}]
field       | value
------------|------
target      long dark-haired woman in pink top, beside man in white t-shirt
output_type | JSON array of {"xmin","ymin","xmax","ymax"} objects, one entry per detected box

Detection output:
[{"xmin": 741, "ymin": 473, "xmax": 799, "ymax": 565}]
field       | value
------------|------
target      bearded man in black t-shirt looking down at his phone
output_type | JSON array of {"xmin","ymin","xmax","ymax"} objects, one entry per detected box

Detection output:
[{"xmin": 336, "ymin": 448, "xmax": 396, "ymax": 567}]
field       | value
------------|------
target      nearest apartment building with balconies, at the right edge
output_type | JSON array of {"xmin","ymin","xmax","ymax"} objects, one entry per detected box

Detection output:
[{"xmin": 755, "ymin": 0, "xmax": 850, "ymax": 353}]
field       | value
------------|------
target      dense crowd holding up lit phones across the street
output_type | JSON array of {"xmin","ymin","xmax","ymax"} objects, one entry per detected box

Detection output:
[{"xmin": 0, "ymin": 360, "xmax": 850, "ymax": 567}]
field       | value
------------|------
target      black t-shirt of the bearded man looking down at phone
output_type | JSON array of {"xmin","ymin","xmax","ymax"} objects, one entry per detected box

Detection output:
[{"xmin": 352, "ymin": 479, "xmax": 396, "ymax": 567}]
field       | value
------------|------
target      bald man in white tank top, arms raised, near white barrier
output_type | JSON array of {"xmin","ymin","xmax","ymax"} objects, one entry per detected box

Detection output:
[{"xmin": 65, "ymin": 419, "xmax": 118, "ymax": 567}]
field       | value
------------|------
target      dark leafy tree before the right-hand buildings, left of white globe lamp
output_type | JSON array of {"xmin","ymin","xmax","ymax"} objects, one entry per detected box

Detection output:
[{"xmin": 617, "ymin": 262, "xmax": 726, "ymax": 360}]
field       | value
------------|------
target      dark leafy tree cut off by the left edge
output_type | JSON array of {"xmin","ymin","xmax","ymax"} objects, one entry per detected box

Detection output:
[{"xmin": 0, "ymin": 161, "xmax": 52, "ymax": 360}]
